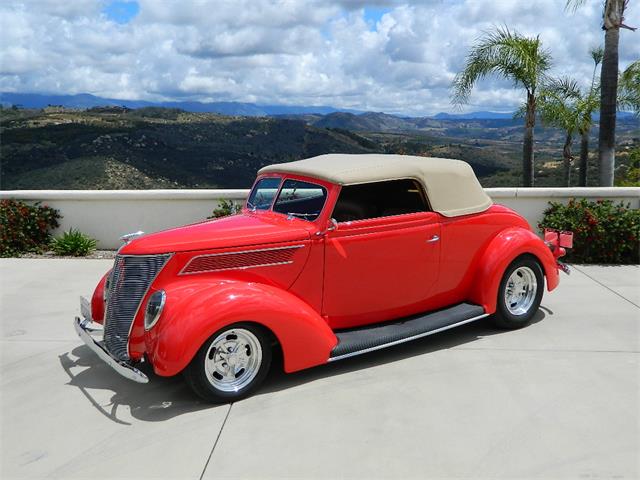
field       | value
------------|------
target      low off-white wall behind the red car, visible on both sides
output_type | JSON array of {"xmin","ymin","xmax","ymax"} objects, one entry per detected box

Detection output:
[{"xmin": 0, "ymin": 187, "xmax": 640, "ymax": 249}]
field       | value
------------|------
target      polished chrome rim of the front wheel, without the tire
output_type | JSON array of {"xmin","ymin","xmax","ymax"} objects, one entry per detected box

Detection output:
[{"xmin": 204, "ymin": 328, "xmax": 262, "ymax": 392}]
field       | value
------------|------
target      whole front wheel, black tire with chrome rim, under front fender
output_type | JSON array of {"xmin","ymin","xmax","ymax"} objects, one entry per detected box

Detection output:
[{"xmin": 184, "ymin": 323, "xmax": 272, "ymax": 402}]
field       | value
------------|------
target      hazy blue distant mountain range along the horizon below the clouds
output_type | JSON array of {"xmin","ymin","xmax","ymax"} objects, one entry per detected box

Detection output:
[{"xmin": 0, "ymin": 92, "xmax": 524, "ymax": 120}]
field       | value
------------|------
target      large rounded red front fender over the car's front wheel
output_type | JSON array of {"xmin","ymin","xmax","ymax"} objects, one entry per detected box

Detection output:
[{"xmin": 145, "ymin": 279, "xmax": 337, "ymax": 376}]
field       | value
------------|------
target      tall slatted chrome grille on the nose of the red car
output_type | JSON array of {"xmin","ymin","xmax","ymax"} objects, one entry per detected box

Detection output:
[{"xmin": 104, "ymin": 254, "xmax": 171, "ymax": 360}]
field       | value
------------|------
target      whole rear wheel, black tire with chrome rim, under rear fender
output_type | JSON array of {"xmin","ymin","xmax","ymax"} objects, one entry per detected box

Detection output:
[{"xmin": 492, "ymin": 256, "xmax": 544, "ymax": 329}]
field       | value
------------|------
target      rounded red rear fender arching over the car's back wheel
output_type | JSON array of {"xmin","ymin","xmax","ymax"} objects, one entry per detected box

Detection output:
[{"xmin": 469, "ymin": 227, "xmax": 559, "ymax": 313}]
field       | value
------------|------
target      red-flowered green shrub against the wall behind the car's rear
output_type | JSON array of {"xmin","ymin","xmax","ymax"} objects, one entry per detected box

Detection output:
[{"xmin": 538, "ymin": 199, "xmax": 640, "ymax": 263}]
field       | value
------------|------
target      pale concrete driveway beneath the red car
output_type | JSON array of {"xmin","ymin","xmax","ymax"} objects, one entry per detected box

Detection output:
[{"xmin": 0, "ymin": 259, "xmax": 640, "ymax": 479}]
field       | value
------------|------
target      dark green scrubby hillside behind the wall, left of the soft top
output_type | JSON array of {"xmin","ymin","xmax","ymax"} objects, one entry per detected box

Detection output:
[{"xmin": 0, "ymin": 109, "xmax": 379, "ymax": 189}]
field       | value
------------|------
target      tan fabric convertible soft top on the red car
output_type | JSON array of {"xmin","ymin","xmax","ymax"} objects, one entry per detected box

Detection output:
[{"xmin": 258, "ymin": 153, "xmax": 492, "ymax": 217}]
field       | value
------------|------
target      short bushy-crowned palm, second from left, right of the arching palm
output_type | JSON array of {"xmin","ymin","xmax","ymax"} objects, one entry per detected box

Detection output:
[{"xmin": 538, "ymin": 78, "xmax": 582, "ymax": 187}]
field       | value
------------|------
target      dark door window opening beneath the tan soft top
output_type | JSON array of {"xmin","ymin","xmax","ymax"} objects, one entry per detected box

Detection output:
[{"xmin": 332, "ymin": 179, "xmax": 429, "ymax": 222}]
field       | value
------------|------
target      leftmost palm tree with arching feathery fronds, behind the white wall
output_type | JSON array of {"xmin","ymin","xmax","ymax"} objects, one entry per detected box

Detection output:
[{"xmin": 452, "ymin": 27, "xmax": 551, "ymax": 187}]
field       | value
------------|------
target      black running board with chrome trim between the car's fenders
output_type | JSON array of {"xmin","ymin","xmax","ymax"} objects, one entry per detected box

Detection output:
[{"xmin": 329, "ymin": 303, "xmax": 489, "ymax": 362}]
